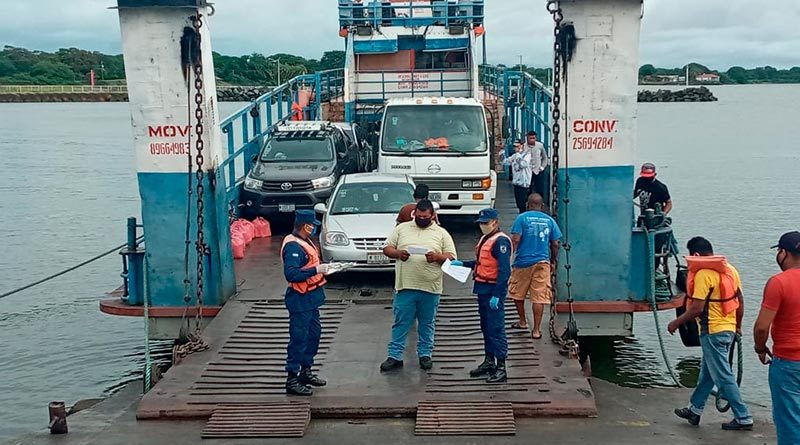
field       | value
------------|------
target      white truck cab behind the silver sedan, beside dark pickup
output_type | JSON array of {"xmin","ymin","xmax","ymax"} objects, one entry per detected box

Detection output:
[{"xmin": 378, "ymin": 97, "xmax": 497, "ymax": 215}]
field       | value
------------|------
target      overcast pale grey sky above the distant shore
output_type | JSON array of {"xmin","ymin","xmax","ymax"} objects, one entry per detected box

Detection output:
[{"xmin": 0, "ymin": 0, "xmax": 800, "ymax": 69}]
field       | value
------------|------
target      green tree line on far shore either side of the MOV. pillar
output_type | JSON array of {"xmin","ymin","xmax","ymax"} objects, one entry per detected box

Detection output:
[{"xmin": 0, "ymin": 46, "xmax": 344, "ymax": 86}]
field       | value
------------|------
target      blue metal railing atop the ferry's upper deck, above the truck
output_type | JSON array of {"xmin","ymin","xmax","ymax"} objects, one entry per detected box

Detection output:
[{"xmin": 339, "ymin": 0, "xmax": 484, "ymax": 29}]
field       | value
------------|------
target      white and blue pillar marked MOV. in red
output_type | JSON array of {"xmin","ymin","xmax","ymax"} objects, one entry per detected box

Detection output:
[{"xmin": 112, "ymin": 0, "xmax": 235, "ymax": 306}]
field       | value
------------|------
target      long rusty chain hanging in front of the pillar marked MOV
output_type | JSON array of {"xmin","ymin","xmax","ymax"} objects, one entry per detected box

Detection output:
[{"xmin": 172, "ymin": 10, "xmax": 210, "ymax": 364}]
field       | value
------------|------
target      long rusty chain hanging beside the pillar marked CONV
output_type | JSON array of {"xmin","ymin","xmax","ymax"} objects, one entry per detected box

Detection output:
[{"xmin": 547, "ymin": 0, "xmax": 578, "ymax": 358}]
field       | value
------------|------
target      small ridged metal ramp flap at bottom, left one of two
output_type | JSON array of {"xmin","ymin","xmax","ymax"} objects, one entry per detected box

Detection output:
[{"xmin": 202, "ymin": 401, "xmax": 311, "ymax": 439}]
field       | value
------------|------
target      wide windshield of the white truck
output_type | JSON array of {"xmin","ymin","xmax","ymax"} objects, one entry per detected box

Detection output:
[{"xmin": 381, "ymin": 105, "xmax": 488, "ymax": 153}]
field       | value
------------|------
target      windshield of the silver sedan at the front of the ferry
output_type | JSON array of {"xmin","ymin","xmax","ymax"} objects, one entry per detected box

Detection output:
[{"xmin": 331, "ymin": 182, "xmax": 414, "ymax": 215}]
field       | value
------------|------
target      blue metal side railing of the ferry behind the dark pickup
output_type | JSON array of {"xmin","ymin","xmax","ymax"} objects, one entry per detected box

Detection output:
[{"xmin": 217, "ymin": 69, "xmax": 344, "ymax": 213}]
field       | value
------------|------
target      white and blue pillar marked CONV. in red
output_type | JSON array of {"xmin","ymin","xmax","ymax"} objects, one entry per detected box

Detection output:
[{"xmin": 559, "ymin": 0, "xmax": 641, "ymax": 301}]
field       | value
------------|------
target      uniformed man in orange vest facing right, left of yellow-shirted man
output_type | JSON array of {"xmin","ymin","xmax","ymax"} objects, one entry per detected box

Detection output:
[{"xmin": 281, "ymin": 210, "xmax": 329, "ymax": 396}]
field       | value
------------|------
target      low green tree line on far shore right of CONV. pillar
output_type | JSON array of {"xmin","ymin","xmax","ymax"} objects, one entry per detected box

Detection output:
[{"xmin": 639, "ymin": 63, "xmax": 800, "ymax": 84}]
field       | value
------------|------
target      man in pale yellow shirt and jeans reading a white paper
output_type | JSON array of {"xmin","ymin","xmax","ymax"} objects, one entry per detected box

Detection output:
[{"xmin": 381, "ymin": 199, "xmax": 456, "ymax": 372}]
